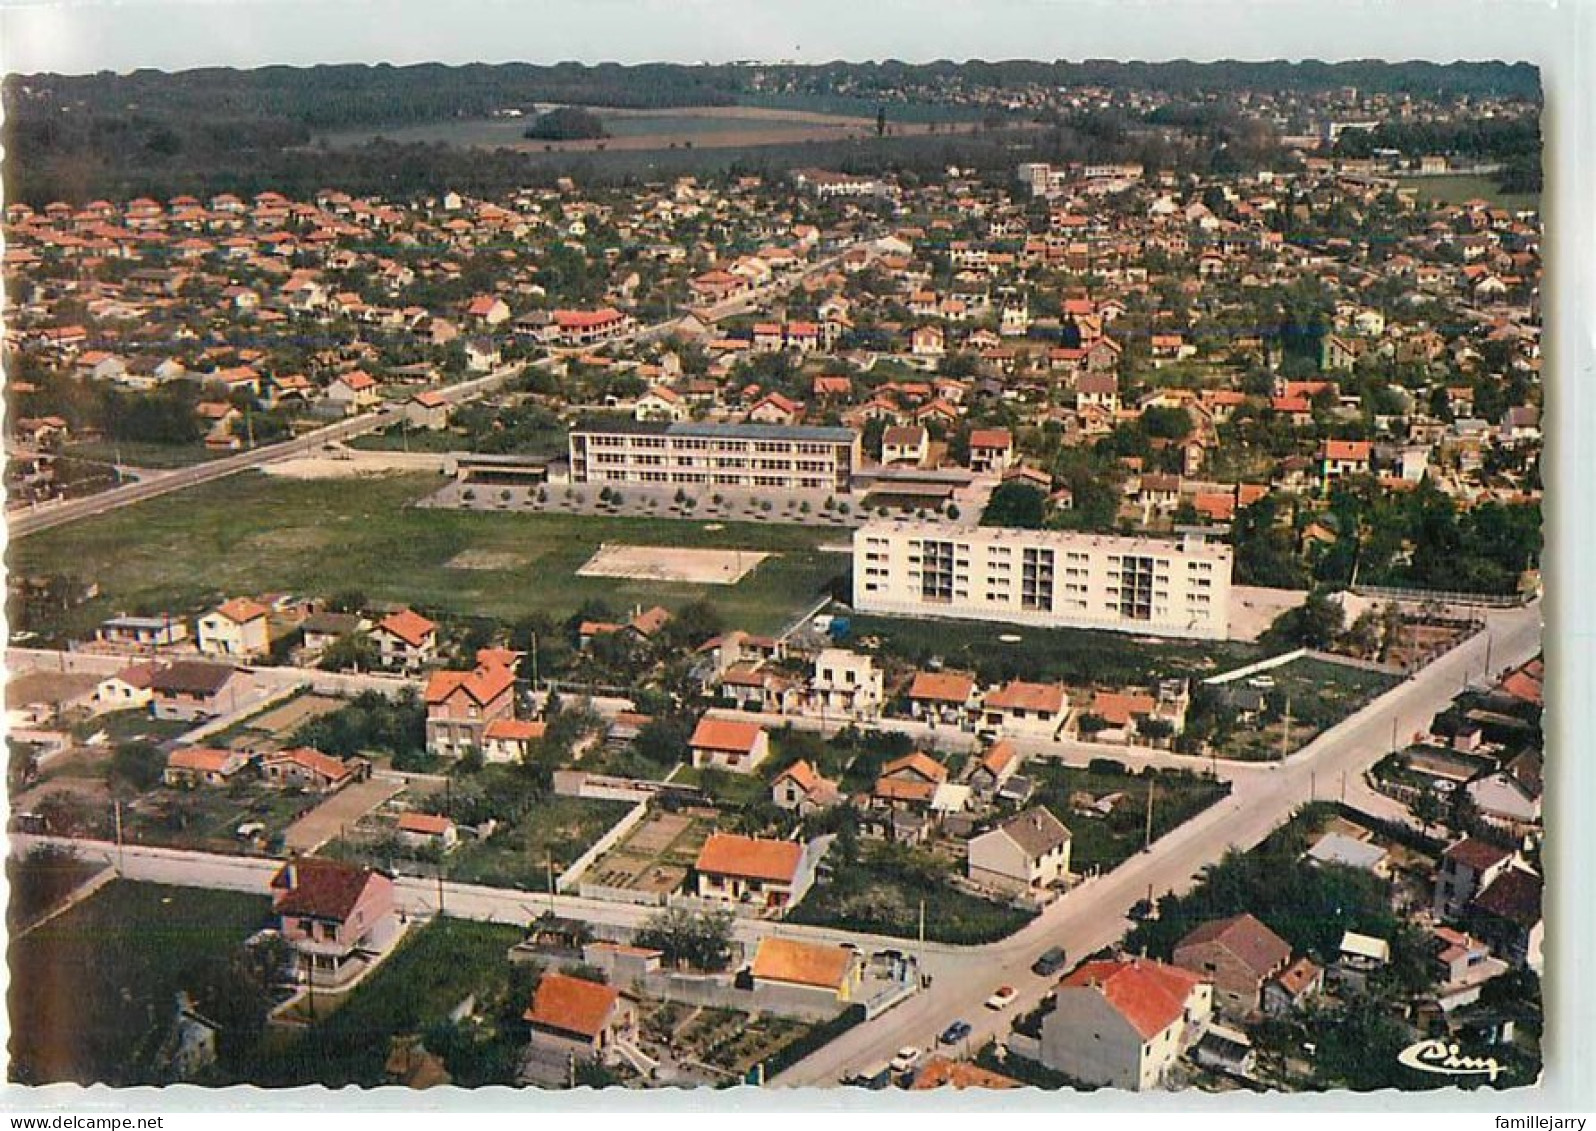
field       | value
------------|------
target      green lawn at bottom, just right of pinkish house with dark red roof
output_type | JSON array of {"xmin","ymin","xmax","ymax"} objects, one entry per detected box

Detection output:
[{"xmin": 239, "ymin": 919, "xmax": 522, "ymax": 1088}]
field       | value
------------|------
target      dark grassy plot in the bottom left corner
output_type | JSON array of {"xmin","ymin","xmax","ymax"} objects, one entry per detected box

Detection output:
[{"xmin": 10, "ymin": 881, "xmax": 270, "ymax": 1085}]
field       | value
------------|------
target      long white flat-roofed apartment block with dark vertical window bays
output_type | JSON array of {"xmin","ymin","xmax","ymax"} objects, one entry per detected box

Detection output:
[{"xmin": 854, "ymin": 520, "xmax": 1231, "ymax": 640}]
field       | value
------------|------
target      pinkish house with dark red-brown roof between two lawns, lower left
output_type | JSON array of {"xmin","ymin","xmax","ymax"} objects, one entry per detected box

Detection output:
[{"xmin": 271, "ymin": 857, "xmax": 399, "ymax": 986}]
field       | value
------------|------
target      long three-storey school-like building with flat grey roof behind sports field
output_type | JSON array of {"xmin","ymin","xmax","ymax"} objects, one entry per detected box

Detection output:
[{"xmin": 570, "ymin": 421, "xmax": 860, "ymax": 493}]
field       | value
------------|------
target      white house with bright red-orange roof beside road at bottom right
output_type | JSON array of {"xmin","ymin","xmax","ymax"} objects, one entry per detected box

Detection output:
[{"xmin": 1042, "ymin": 959, "xmax": 1213, "ymax": 1091}]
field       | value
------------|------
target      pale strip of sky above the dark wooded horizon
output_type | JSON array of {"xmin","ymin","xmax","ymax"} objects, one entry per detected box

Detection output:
[{"xmin": 0, "ymin": 0, "xmax": 1586, "ymax": 73}]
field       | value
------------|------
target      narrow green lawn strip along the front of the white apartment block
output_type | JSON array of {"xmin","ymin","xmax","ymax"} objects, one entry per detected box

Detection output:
[{"xmin": 852, "ymin": 616, "xmax": 1261, "ymax": 686}]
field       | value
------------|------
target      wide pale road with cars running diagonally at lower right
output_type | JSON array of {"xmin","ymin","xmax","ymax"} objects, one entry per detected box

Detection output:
[{"xmin": 772, "ymin": 600, "xmax": 1542, "ymax": 1085}]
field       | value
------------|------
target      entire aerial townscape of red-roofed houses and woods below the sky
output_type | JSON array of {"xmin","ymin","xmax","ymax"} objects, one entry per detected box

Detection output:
[{"xmin": 3, "ymin": 41, "xmax": 1543, "ymax": 1093}]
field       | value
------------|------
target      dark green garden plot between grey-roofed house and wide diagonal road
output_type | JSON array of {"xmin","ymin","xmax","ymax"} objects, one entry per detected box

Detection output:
[{"xmin": 1025, "ymin": 755, "xmax": 1229, "ymax": 874}]
